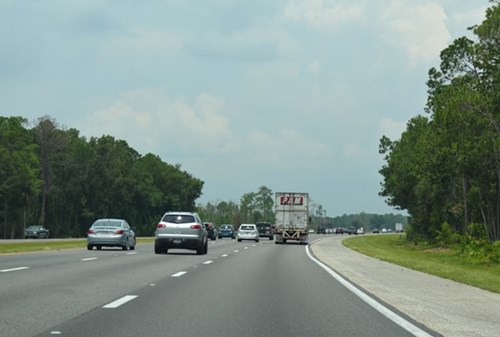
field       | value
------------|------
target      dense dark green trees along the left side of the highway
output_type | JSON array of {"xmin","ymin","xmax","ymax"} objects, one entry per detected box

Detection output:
[{"xmin": 0, "ymin": 116, "xmax": 204, "ymax": 239}]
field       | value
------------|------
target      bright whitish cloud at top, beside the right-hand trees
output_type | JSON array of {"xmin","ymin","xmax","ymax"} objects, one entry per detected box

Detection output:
[{"xmin": 381, "ymin": 0, "xmax": 451, "ymax": 67}]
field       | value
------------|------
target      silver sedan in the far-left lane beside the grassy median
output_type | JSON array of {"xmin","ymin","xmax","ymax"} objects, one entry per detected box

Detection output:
[{"xmin": 87, "ymin": 219, "xmax": 136, "ymax": 250}]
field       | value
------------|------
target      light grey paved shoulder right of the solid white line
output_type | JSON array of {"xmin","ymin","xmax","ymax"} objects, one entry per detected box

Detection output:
[{"xmin": 310, "ymin": 236, "xmax": 500, "ymax": 337}]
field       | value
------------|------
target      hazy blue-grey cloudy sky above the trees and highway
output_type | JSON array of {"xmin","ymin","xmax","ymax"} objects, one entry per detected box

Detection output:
[{"xmin": 0, "ymin": 0, "xmax": 490, "ymax": 216}]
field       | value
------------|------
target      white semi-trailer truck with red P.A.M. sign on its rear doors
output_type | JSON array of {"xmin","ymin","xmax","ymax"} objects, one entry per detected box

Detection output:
[{"xmin": 274, "ymin": 192, "xmax": 309, "ymax": 244}]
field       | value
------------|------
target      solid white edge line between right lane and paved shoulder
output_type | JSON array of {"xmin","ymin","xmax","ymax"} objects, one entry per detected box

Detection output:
[{"xmin": 306, "ymin": 245, "xmax": 433, "ymax": 337}]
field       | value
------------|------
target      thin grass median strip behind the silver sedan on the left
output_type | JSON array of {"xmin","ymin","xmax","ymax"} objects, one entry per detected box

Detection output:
[{"xmin": 0, "ymin": 238, "xmax": 154, "ymax": 254}]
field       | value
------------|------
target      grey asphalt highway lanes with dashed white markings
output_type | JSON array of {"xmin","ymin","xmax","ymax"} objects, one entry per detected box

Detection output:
[{"xmin": 0, "ymin": 239, "xmax": 437, "ymax": 337}]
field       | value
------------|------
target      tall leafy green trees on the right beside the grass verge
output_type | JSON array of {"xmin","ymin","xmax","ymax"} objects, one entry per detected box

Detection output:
[{"xmin": 379, "ymin": 1, "xmax": 500, "ymax": 242}]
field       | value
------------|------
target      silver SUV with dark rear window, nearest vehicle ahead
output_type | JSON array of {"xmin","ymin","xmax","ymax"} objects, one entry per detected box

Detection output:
[{"xmin": 155, "ymin": 212, "xmax": 208, "ymax": 255}]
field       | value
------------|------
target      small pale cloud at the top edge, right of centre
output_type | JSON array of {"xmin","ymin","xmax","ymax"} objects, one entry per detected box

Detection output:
[{"xmin": 285, "ymin": 0, "xmax": 364, "ymax": 30}]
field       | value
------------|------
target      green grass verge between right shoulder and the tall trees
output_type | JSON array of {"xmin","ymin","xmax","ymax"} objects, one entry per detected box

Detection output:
[{"xmin": 342, "ymin": 234, "xmax": 500, "ymax": 293}]
